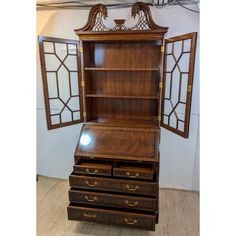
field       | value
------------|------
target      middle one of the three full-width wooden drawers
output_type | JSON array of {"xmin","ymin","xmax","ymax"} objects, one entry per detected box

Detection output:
[{"xmin": 69, "ymin": 189, "xmax": 158, "ymax": 211}]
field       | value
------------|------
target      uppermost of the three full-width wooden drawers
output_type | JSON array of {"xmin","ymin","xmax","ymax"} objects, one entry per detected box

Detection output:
[{"xmin": 69, "ymin": 174, "xmax": 158, "ymax": 196}]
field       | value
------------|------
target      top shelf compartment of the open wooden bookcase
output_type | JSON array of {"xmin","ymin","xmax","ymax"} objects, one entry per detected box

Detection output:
[{"xmin": 83, "ymin": 41, "xmax": 161, "ymax": 68}]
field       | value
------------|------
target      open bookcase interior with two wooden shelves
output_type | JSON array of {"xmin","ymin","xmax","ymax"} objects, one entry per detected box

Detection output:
[{"xmin": 83, "ymin": 41, "xmax": 161, "ymax": 121}]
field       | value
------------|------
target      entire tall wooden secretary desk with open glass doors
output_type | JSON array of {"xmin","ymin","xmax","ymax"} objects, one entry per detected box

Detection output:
[{"xmin": 39, "ymin": 2, "xmax": 196, "ymax": 230}]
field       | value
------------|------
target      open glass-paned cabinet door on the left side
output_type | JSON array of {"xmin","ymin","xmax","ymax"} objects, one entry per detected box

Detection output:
[{"xmin": 39, "ymin": 36, "xmax": 83, "ymax": 129}]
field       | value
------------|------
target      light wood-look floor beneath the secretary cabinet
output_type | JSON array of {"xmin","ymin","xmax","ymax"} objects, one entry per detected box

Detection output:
[{"xmin": 37, "ymin": 176, "xmax": 199, "ymax": 236}]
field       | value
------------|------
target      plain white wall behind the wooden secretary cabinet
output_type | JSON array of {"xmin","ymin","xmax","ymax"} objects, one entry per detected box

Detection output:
[{"xmin": 37, "ymin": 6, "xmax": 199, "ymax": 190}]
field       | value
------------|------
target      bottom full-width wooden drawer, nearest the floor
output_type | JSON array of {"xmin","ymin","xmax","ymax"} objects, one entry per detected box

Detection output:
[{"xmin": 67, "ymin": 204, "xmax": 156, "ymax": 231}]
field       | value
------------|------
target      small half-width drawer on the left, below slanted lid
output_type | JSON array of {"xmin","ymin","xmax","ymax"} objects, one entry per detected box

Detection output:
[{"xmin": 73, "ymin": 159, "xmax": 112, "ymax": 176}]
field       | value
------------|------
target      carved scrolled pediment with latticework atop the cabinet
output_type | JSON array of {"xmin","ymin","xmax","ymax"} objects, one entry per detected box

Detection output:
[{"xmin": 76, "ymin": 2, "xmax": 167, "ymax": 31}]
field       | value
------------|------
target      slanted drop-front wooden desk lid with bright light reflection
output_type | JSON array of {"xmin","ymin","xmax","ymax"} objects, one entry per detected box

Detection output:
[{"xmin": 75, "ymin": 124, "xmax": 159, "ymax": 162}]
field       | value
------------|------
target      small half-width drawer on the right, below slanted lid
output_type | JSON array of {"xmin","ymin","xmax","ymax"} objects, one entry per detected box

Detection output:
[{"xmin": 113, "ymin": 162, "xmax": 155, "ymax": 180}]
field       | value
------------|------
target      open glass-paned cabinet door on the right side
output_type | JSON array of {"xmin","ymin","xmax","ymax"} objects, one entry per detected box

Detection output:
[{"xmin": 161, "ymin": 33, "xmax": 197, "ymax": 138}]
